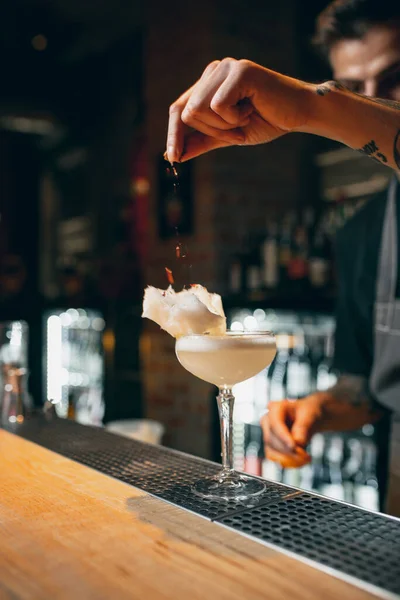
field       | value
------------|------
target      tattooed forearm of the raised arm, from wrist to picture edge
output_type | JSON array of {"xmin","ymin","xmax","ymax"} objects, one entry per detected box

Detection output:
[{"xmin": 301, "ymin": 81, "xmax": 400, "ymax": 171}]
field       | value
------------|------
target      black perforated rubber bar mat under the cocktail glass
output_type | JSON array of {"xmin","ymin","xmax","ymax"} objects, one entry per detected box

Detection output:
[{"xmin": 10, "ymin": 419, "xmax": 400, "ymax": 598}]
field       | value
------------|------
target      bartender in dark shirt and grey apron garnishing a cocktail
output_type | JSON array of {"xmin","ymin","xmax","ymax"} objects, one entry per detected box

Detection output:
[{"xmin": 166, "ymin": 0, "xmax": 400, "ymax": 514}]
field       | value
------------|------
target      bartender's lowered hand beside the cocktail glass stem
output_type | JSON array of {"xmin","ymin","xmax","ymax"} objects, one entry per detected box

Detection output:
[{"xmin": 261, "ymin": 394, "xmax": 322, "ymax": 468}]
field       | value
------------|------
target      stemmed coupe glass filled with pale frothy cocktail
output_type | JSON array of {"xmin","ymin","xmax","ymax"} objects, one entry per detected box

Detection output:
[{"xmin": 175, "ymin": 331, "xmax": 276, "ymax": 500}]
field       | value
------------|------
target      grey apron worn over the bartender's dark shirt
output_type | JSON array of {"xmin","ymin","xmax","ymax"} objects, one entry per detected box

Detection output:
[{"xmin": 370, "ymin": 177, "xmax": 400, "ymax": 517}]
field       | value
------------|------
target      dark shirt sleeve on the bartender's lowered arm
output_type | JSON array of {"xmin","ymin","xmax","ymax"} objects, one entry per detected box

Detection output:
[{"xmin": 334, "ymin": 226, "xmax": 373, "ymax": 377}]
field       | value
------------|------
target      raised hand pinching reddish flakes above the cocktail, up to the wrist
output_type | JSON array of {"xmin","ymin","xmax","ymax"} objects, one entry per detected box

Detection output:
[{"xmin": 166, "ymin": 58, "xmax": 310, "ymax": 162}]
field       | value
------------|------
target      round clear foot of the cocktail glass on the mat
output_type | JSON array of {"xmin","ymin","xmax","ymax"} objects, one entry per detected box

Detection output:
[{"xmin": 192, "ymin": 473, "xmax": 265, "ymax": 500}]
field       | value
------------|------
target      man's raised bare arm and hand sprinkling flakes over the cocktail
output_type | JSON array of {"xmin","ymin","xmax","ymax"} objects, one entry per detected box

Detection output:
[{"xmin": 164, "ymin": 58, "xmax": 400, "ymax": 170}]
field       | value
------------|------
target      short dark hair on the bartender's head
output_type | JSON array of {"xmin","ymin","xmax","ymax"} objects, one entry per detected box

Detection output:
[{"xmin": 312, "ymin": 0, "xmax": 400, "ymax": 58}]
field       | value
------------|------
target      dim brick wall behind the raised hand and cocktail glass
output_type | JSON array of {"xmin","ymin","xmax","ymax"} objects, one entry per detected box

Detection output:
[{"xmin": 141, "ymin": 0, "xmax": 312, "ymax": 456}]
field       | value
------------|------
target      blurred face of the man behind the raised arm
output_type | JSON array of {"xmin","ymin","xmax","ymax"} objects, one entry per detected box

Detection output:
[{"xmin": 329, "ymin": 23, "xmax": 400, "ymax": 101}]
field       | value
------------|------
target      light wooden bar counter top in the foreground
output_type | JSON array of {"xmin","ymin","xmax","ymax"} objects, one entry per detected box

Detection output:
[{"xmin": 0, "ymin": 431, "xmax": 390, "ymax": 600}]
